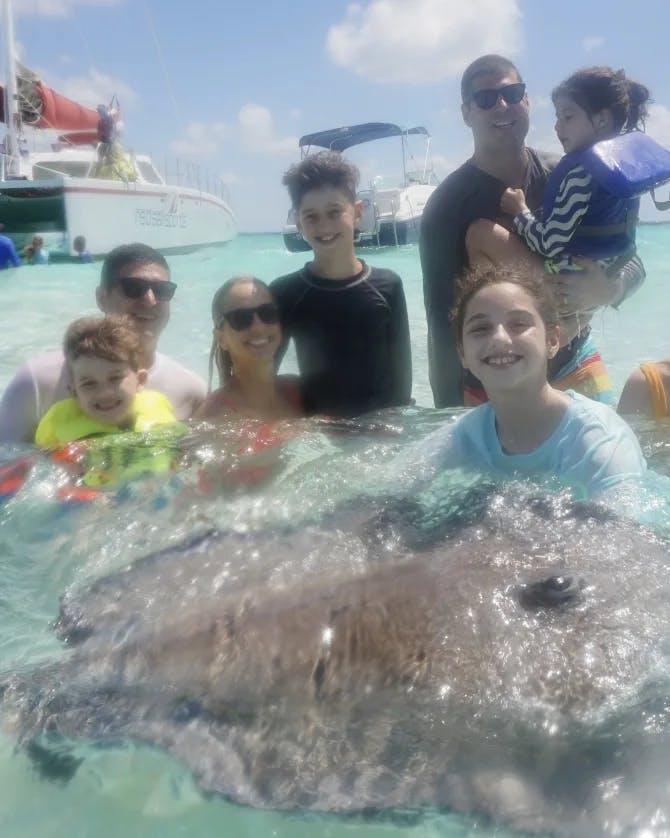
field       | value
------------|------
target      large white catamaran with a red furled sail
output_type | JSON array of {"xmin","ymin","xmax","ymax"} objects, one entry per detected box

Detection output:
[{"xmin": 0, "ymin": 0, "xmax": 237, "ymax": 258}]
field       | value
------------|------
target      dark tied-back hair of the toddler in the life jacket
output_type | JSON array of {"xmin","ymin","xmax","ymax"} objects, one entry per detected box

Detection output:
[{"xmin": 551, "ymin": 67, "xmax": 650, "ymax": 132}]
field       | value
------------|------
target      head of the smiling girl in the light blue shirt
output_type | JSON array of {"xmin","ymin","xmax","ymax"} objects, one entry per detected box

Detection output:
[{"xmin": 452, "ymin": 265, "xmax": 559, "ymax": 401}]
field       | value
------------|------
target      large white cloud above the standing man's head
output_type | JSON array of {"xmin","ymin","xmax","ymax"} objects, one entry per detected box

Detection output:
[{"xmin": 326, "ymin": 0, "xmax": 522, "ymax": 84}]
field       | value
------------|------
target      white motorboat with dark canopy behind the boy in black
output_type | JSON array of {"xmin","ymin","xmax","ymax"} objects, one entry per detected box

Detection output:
[{"xmin": 282, "ymin": 122, "xmax": 438, "ymax": 252}]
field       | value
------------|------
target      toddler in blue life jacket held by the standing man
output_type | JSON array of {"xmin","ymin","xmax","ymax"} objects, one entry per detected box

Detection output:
[{"xmin": 500, "ymin": 67, "xmax": 670, "ymax": 273}]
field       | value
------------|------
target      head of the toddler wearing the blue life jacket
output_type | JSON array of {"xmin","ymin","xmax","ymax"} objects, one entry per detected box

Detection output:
[{"xmin": 551, "ymin": 67, "xmax": 650, "ymax": 153}]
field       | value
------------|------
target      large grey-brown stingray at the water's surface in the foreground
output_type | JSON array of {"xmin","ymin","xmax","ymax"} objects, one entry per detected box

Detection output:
[{"xmin": 0, "ymin": 496, "xmax": 670, "ymax": 836}]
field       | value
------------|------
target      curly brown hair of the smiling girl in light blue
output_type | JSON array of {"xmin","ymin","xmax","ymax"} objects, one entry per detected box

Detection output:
[{"xmin": 450, "ymin": 263, "xmax": 559, "ymax": 345}]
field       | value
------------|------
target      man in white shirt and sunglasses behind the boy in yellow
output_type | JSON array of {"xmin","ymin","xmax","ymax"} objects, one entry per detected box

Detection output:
[{"xmin": 0, "ymin": 243, "xmax": 206, "ymax": 442}]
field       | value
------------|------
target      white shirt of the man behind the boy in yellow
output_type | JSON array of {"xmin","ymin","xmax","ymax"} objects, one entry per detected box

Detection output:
[{"xmin": 0, "ymin": 350, "xmax": 207, "ymax": 443}]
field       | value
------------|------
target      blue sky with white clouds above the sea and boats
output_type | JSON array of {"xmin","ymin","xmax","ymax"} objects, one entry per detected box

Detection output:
[{"xmin": 5, "ymin": 0, "xmax": 670, "ymax": 231}]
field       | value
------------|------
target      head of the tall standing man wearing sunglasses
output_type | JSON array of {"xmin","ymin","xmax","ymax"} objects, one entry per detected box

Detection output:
[{"xmin": 461, "ymin": 54, "xmax": 529, "ymax": 152}]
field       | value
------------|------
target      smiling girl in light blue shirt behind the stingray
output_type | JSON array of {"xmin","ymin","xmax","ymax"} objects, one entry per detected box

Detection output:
[{"xmin": 434, "ymin": 266, "xmax": 646, "ymax": 497}]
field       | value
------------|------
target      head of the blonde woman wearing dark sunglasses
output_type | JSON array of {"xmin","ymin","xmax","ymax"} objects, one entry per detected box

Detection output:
[{"xmin": 209, "ymin": 276, "xmax": 282, "ymax": 390}]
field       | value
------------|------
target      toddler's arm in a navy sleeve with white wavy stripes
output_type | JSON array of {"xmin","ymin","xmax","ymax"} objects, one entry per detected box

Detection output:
[{"xmin": 513, "ymin": 166, "xmax": 593, "ymax": 259}]
